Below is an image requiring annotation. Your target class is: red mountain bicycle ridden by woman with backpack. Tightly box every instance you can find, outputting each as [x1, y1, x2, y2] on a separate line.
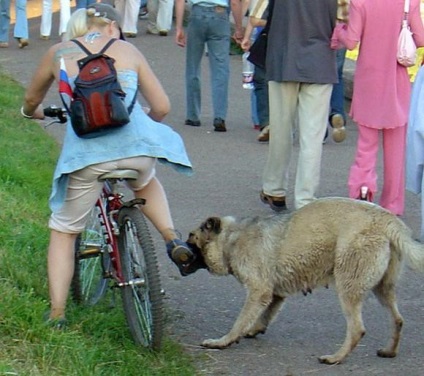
[44, 106, 164, 350]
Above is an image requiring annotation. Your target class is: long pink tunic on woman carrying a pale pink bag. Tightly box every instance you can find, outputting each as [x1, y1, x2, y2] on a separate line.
[332, 0, 424, 129]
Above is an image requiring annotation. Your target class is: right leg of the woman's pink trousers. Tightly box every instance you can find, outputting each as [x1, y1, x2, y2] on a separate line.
[380, 127, 406, 215]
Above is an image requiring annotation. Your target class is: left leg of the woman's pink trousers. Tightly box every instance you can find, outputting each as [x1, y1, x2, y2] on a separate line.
[348, 124, 379, 198]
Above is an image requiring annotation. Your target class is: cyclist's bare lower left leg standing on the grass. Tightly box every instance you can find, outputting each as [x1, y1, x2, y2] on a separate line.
[47, 230, 77, 319]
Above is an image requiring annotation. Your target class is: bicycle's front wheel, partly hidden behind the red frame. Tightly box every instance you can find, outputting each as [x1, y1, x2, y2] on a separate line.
[71, 207, 111, 306]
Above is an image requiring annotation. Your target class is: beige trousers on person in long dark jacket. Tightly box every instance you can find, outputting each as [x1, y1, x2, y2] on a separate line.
[263, 81, 333, 209]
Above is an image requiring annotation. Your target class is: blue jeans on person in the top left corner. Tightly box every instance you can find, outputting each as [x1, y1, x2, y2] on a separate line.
[0, 0, 28, 42]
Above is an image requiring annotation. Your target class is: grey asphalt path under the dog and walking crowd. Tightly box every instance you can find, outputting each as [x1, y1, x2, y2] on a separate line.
[0, 0, 424, 376]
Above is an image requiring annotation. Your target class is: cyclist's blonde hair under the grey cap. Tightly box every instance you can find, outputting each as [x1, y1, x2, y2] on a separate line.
[63, 8, 111, 41]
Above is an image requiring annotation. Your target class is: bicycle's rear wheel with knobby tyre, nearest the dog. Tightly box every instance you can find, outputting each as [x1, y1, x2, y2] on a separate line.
[118, 207, 163, 350]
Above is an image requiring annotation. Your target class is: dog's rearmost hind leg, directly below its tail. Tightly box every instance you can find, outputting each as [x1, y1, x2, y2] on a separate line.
[373, 259, 403, 358]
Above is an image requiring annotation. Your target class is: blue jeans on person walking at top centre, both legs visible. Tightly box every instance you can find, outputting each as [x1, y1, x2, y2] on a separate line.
[186, 5, 231, 120]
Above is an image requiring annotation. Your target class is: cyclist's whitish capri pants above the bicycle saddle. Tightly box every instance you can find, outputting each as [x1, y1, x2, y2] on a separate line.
[49, 157, 156, 234]
